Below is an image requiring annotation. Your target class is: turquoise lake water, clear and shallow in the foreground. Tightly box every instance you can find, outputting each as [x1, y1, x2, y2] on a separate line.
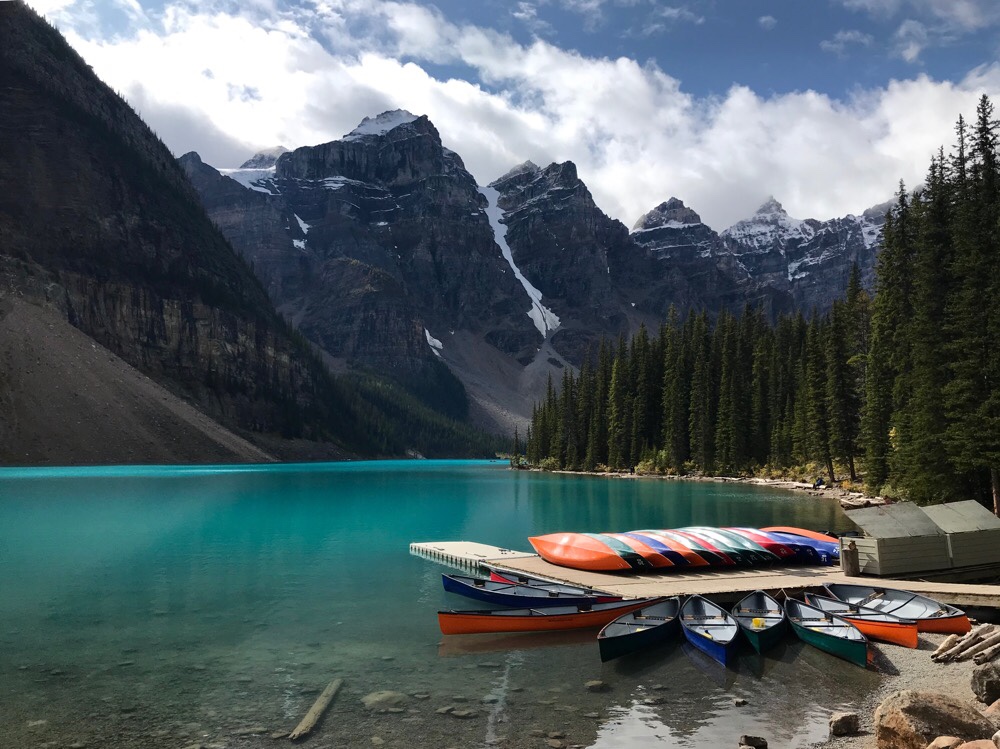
[0, 461, 878, 749]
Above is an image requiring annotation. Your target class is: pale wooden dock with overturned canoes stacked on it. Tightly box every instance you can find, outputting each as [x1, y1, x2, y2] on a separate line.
[410, 541, 1000, 609]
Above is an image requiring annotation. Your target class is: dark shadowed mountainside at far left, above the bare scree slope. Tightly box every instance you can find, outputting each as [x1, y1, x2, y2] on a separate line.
[0, 2, 368, 450]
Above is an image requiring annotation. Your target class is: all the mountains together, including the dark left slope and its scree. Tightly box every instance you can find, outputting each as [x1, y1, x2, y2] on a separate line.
[0, 0, 884, 464]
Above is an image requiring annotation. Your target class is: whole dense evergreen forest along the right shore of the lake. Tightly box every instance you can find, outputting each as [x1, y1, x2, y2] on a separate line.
[526, 96, 1000, 511]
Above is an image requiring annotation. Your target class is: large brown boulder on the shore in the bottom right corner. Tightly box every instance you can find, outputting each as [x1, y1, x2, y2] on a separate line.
[875, 689, 996, 749]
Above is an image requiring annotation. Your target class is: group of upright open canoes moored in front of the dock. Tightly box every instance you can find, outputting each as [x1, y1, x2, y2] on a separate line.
[438, 571, 970, 667]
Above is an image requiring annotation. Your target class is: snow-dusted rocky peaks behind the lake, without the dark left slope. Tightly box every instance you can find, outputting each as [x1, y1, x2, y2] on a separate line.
[179, 110, 888, 432]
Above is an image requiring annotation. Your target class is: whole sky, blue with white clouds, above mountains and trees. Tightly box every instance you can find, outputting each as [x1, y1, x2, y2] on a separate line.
[28, 0, 1000, 230]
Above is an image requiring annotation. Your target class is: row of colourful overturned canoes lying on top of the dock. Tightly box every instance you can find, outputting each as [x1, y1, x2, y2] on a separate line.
[528, 526, 840, 572]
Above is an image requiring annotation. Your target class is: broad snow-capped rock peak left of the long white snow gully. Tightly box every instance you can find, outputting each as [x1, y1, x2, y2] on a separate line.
[180, 111, 543, 426]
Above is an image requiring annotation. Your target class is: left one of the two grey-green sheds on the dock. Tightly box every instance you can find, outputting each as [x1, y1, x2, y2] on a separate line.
[841, 502, 951, 575]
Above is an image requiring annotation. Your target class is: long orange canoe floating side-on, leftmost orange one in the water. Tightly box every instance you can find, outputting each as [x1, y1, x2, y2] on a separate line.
[438, 598, 662, 635]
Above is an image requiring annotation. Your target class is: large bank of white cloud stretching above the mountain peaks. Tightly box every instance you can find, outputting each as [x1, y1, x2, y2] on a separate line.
[31, 0, 1000, 229]
